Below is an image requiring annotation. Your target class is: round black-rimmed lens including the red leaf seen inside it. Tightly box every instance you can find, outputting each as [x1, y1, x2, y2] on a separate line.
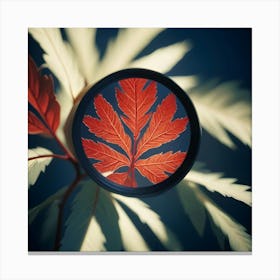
[72, 69, 200, 197]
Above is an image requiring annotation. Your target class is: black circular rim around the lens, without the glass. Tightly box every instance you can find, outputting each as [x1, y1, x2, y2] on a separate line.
[72, 68, 201, 197]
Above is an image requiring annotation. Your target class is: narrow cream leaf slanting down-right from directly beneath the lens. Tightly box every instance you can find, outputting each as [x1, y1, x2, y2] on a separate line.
[114, 195, 181, 251]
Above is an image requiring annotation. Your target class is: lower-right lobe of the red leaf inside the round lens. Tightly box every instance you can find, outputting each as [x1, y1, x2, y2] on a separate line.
[135, 152, 186, 184]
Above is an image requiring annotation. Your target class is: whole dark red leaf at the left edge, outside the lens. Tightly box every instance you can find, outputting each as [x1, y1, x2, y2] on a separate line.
[28, 57, 60, 135]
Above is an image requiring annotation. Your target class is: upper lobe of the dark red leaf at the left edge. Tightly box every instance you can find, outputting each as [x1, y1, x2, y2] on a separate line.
[28, 57, 60, 133]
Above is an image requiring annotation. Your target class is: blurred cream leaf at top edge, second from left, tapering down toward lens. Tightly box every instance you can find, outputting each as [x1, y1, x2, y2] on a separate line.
[65, 28, 99, 84]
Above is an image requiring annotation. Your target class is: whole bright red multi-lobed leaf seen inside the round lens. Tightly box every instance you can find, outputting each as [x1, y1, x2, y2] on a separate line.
[82, 78, 189, 187]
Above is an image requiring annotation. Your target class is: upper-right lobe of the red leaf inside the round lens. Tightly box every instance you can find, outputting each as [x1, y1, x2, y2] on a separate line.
[136, 93, 188, 159]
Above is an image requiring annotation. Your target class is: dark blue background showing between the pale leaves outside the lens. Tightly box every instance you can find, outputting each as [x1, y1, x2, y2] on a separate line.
[28, 28, 251, 251]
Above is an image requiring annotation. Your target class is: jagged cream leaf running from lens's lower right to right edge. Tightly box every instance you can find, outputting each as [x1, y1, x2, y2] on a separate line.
[184, 167, 252, 206]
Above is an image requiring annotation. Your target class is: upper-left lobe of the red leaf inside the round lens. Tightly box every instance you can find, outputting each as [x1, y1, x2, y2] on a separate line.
[83, 94, 131, 157]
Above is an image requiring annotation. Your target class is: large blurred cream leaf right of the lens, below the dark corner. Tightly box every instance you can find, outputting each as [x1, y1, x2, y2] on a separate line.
[190, 82, 252, 148]
